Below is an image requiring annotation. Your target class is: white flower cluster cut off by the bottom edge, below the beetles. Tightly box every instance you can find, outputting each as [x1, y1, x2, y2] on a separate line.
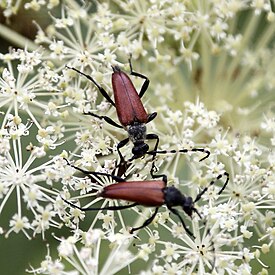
[28, 229, 137, 274]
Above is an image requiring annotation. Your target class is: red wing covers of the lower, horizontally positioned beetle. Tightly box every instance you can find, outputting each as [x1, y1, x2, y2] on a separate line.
[101, 180, 166, 206]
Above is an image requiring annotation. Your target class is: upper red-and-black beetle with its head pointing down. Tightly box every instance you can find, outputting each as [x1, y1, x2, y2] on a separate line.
[67, 58, 159, 162]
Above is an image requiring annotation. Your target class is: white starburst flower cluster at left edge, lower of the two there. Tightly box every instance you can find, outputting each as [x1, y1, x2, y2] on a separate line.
[0, 114, 60, 239]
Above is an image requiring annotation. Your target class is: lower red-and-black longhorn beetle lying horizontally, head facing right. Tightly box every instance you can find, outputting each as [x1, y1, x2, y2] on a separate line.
[62, 159, 229, 238]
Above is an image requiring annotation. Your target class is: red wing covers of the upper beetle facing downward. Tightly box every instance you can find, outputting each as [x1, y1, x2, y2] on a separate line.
[112, 67, 148, 126]
